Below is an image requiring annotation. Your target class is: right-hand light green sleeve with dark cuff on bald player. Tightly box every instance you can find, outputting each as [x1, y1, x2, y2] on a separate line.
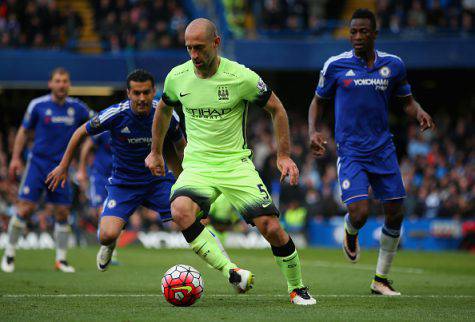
[240, 68, 272, 107]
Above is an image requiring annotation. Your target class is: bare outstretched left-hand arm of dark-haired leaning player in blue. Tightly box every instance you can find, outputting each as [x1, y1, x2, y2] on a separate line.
[45, 123, 88, 191]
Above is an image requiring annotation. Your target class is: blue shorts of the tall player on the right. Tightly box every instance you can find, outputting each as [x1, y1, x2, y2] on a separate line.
[337, 145, 406, 205]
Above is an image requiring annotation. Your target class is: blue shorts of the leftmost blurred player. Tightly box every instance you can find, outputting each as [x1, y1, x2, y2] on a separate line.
[18, 155, 72, 206]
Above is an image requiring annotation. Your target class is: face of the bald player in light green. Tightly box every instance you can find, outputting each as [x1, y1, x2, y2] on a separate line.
[185, 31, 221, 71]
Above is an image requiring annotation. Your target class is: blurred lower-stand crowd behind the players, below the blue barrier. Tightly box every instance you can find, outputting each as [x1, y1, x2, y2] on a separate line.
[0, 110, 475, 232]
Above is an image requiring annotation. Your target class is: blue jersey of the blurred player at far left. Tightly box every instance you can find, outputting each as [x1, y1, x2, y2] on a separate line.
[22, 95, 94, 162]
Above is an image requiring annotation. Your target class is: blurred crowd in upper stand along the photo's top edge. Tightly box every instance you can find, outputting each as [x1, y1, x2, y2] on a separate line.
[0, 0, 475, 52]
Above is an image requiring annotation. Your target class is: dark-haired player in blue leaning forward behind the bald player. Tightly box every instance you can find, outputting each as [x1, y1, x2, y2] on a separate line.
[47, 69, 186, 271]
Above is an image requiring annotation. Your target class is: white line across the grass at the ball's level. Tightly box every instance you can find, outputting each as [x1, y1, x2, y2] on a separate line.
[0, 294, 475, 299]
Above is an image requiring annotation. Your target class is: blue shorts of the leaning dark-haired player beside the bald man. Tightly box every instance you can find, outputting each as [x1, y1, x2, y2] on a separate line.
[101, 180, 175, 223]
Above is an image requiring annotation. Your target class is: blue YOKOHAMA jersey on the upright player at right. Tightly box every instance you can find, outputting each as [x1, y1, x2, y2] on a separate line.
[315, 51, 411, 156]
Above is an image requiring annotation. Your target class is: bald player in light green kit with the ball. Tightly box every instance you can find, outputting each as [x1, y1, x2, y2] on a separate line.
[146, 18, 316, 305]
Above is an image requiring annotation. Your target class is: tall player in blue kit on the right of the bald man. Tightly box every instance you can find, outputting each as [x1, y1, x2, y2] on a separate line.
[309, 9, 434, 295]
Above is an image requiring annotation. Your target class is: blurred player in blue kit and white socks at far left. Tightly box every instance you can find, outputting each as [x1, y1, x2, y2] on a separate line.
[1, 68, 92, 273]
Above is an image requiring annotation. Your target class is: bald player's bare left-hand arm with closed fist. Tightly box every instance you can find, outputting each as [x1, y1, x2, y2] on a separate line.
[145, 99, 173, 176]
